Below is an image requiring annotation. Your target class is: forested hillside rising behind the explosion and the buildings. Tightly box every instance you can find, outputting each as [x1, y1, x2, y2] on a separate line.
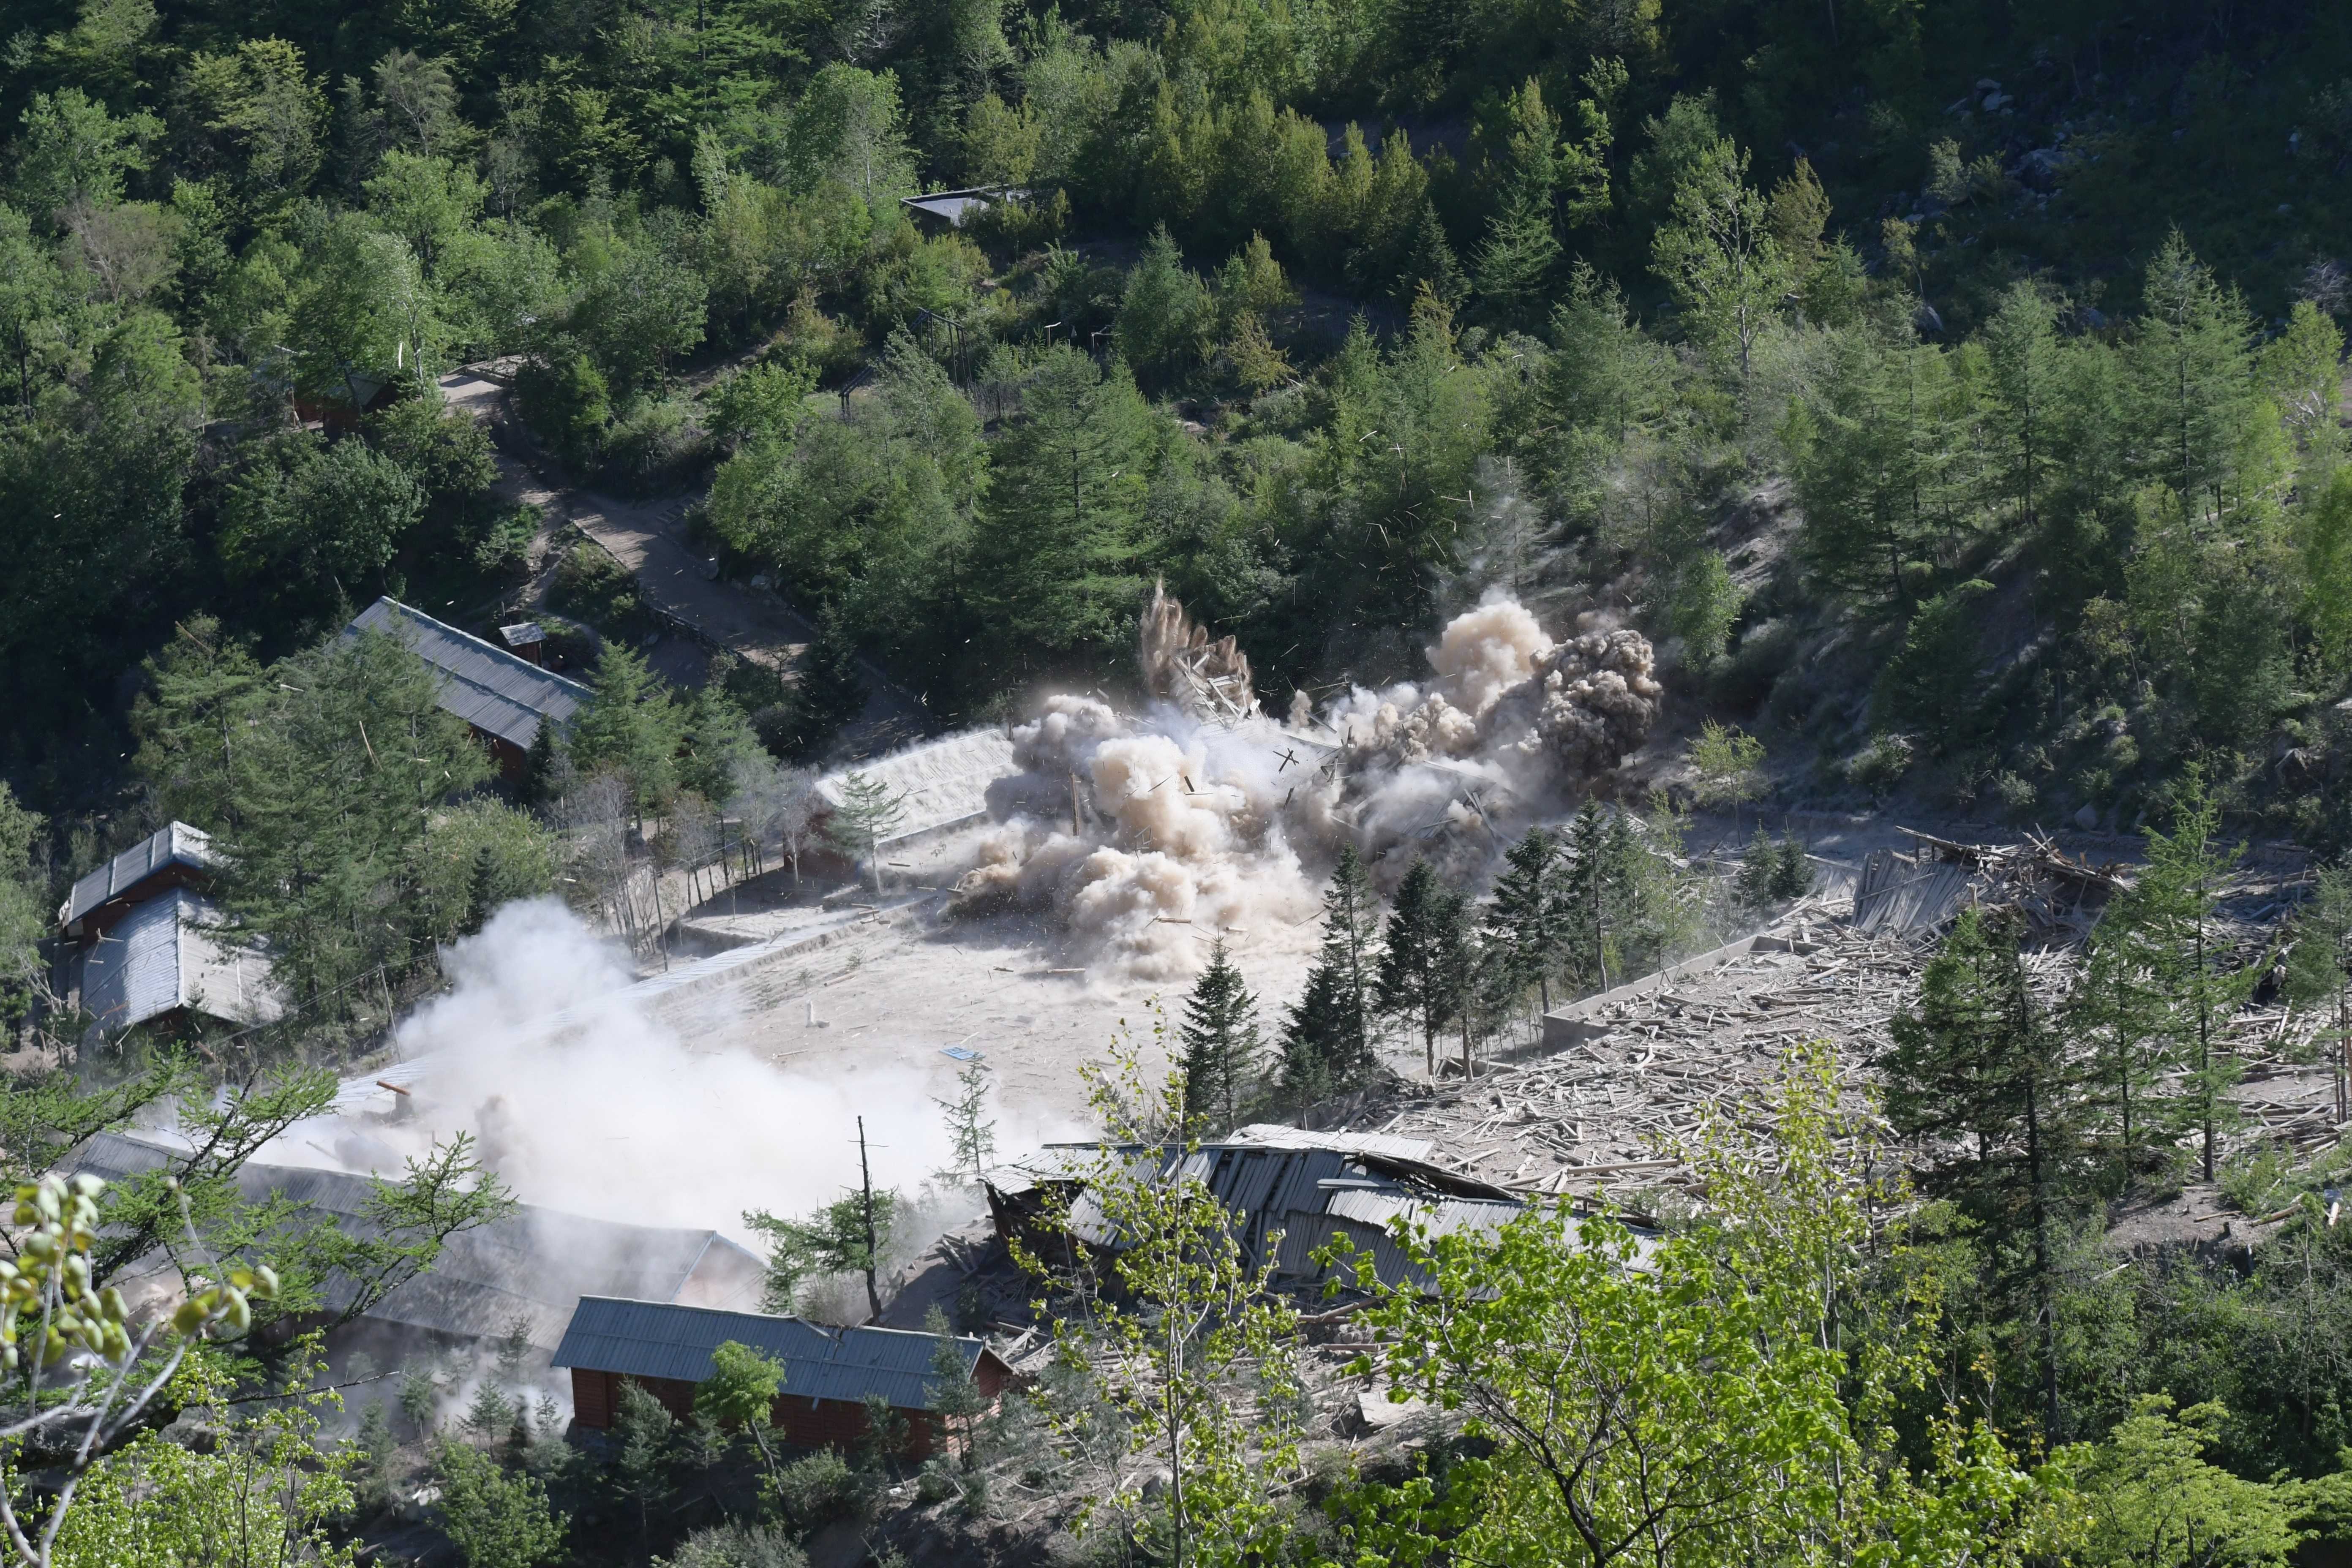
[0, 0, 2352, 860]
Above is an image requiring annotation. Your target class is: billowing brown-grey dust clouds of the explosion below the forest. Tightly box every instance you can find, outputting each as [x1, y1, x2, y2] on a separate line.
[957, 590, 1660, 980]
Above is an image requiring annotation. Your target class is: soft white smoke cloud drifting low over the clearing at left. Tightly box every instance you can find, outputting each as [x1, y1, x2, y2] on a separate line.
[261, 898, 1082, 1251]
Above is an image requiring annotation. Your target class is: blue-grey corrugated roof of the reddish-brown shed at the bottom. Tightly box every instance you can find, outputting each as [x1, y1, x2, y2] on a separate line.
[555, 1295, 983, 1410]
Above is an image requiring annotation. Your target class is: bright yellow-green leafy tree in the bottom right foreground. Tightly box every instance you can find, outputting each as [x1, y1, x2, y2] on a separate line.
[1341, 1053, 2063, 1563]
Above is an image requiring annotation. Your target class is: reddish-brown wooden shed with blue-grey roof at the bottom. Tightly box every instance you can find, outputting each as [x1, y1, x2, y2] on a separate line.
[555, 1295, 1011, 1460]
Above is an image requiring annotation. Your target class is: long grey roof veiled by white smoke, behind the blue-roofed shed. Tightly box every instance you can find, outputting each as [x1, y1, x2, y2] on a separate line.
[71, 1133, 764, 1349]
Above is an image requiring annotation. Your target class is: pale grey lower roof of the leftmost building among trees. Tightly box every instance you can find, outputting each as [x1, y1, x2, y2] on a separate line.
[82, 889, 285, 1030]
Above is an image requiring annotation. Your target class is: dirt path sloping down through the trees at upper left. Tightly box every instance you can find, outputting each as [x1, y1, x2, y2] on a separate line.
[440, 371, 929, 752]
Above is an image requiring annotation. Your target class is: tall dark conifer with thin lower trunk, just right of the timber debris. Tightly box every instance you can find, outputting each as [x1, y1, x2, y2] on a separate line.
[1879, 910, 2084, 1439]
